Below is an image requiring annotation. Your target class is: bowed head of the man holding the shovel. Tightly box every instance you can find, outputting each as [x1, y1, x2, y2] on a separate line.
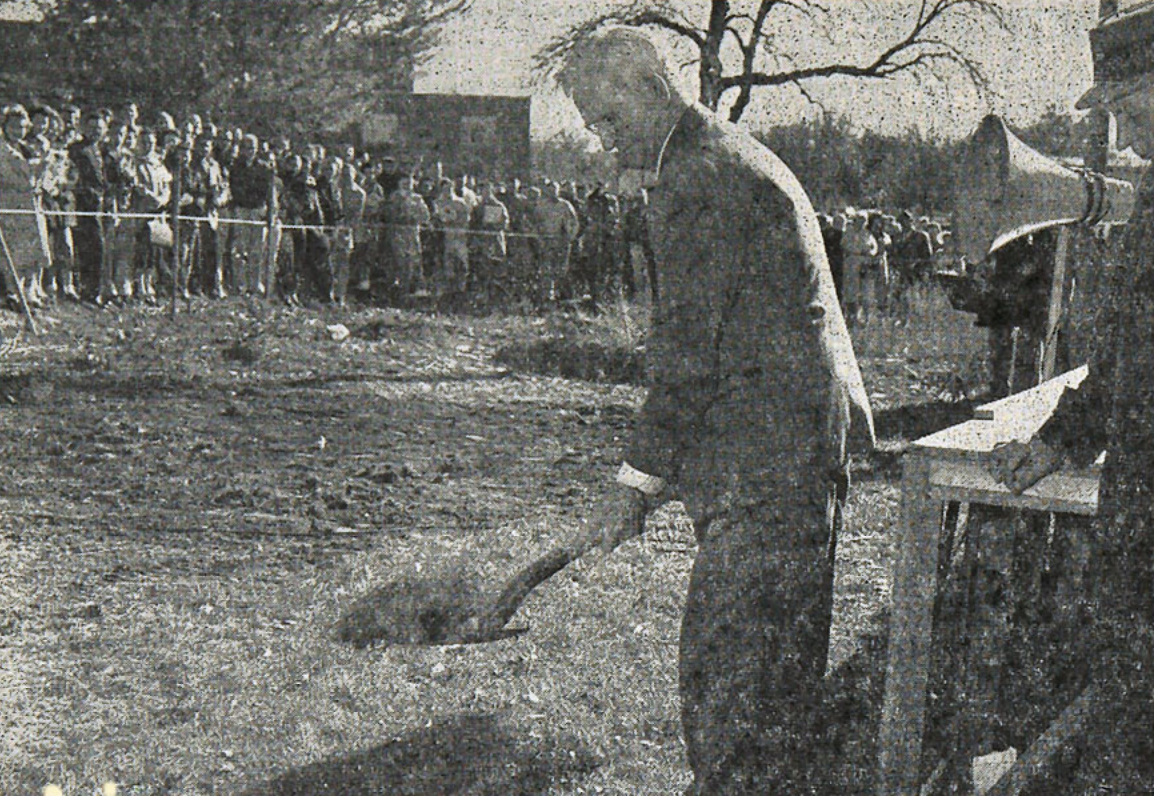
[557, 28, 688, 170]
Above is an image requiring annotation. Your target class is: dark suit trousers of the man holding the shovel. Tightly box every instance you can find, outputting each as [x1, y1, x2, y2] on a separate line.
[680, 485, 840, 796]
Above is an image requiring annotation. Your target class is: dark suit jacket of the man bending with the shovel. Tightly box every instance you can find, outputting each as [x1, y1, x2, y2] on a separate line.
[627, 105, 874, 516]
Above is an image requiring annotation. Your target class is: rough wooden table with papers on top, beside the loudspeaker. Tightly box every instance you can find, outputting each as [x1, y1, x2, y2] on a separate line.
[878, 367, 1099, 796]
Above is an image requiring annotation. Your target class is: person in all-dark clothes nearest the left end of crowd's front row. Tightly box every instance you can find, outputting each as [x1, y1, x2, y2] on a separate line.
[68, 111, 113, 300]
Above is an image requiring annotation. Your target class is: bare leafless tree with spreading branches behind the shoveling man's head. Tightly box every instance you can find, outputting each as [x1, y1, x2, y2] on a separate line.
[535, 0, 1007, 121]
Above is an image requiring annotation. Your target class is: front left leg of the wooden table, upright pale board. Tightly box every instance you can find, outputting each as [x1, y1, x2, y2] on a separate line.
[877, 451, 942, 796]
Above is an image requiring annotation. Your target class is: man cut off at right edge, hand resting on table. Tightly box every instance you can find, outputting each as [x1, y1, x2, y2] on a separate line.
[995, 5, 1154, 794]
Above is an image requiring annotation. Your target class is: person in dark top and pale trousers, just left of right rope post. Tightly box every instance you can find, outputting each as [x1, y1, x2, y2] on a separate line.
[227, 135, 279, 295]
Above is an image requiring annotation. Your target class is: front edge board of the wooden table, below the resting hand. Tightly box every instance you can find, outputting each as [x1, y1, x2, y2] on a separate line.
[930, 461, 1099, 517]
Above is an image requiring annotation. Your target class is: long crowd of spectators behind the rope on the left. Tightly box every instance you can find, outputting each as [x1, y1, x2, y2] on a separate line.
[0, 99, 657, 308]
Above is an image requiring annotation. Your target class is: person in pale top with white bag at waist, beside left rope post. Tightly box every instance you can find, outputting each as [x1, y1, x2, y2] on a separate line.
[133, 129, 172, 303]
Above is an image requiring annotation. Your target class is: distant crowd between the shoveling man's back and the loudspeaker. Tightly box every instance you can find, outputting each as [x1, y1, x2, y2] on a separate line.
[818, 208, 950, 328]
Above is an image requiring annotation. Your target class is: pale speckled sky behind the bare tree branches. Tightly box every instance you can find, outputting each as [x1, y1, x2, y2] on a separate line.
[417, 0, 1103, 137]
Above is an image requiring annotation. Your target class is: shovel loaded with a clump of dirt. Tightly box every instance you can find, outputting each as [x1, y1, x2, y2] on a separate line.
[336, 526, 601, 647]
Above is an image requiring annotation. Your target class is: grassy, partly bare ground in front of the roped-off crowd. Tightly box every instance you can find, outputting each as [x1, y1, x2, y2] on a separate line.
[0, 287, 982, 796]
